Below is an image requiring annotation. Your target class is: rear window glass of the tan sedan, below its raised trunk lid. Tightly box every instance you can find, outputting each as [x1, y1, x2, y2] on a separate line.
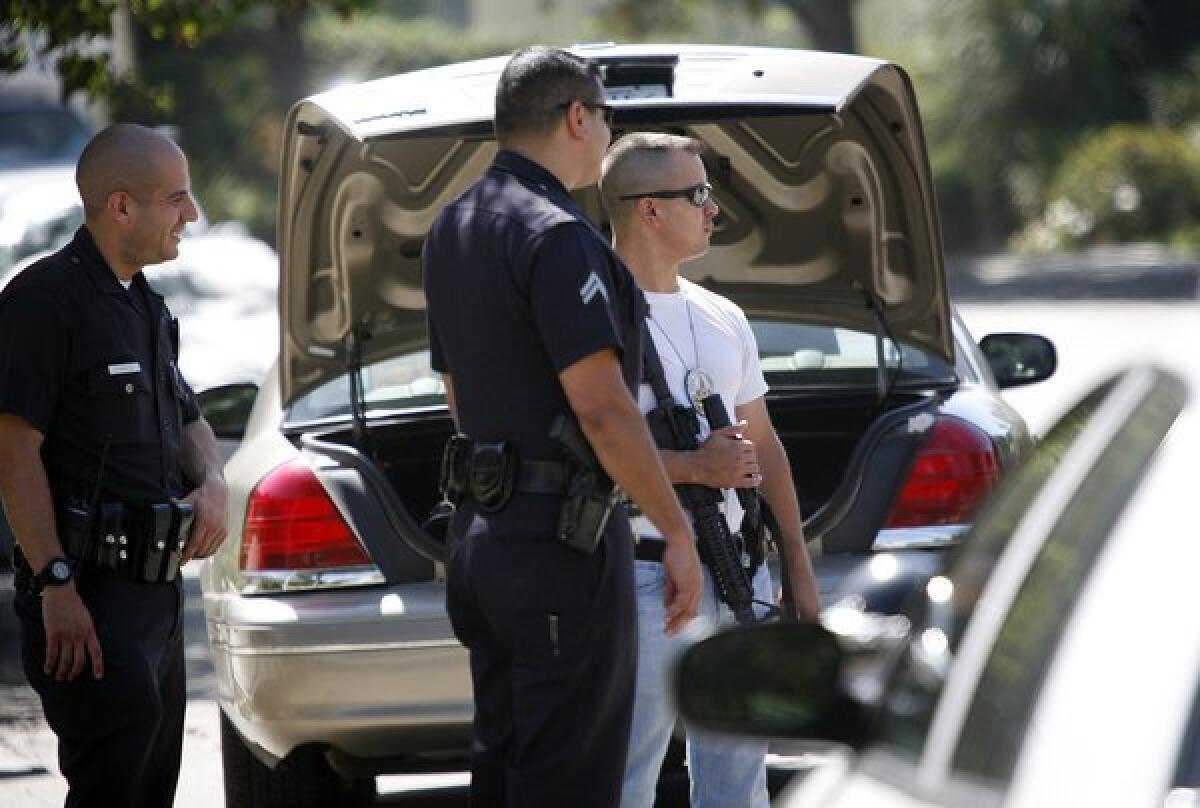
[288, 321, 954, 423]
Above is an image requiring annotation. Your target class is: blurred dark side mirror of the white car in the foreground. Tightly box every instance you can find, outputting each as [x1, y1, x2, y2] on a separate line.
[674, 623, 865, 747]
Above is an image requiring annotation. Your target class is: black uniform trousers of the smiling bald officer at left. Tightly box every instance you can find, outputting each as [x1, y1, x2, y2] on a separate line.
[16, 567, 187, 808]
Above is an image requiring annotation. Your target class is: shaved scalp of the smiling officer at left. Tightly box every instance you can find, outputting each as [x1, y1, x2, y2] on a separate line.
[76, 124, 182, 222]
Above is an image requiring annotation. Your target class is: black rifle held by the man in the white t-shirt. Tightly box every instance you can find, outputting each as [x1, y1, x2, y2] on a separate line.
[644, 324, 757, 623]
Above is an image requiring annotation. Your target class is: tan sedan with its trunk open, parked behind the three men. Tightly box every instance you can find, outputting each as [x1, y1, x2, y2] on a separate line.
[202, 46, 1055, 806]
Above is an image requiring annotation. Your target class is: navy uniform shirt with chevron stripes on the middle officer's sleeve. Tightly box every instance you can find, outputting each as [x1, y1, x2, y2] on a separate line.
[422, 151, 644, 533]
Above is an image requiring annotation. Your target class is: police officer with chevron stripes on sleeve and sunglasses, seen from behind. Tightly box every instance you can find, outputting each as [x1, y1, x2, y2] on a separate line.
[424, 47, 701, 808]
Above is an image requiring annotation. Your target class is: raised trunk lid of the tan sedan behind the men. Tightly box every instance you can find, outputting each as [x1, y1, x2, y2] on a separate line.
[278, 46, 953, 406]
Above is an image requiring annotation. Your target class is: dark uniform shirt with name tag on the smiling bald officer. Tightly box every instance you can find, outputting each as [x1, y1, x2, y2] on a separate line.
[0, 227, 199, 504]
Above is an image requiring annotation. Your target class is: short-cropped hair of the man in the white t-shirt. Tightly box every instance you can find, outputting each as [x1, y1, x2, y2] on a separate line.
[600, 132, 704, 227]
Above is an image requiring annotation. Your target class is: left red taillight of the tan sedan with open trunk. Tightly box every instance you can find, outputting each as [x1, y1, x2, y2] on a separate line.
[240, 460, 373, 571]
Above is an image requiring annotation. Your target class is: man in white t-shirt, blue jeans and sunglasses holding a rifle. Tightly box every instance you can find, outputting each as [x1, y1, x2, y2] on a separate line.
[600, 132, 817, 808]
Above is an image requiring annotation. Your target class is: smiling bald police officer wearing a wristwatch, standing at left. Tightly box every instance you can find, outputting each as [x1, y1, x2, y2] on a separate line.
[0, 124, 227, 808]
